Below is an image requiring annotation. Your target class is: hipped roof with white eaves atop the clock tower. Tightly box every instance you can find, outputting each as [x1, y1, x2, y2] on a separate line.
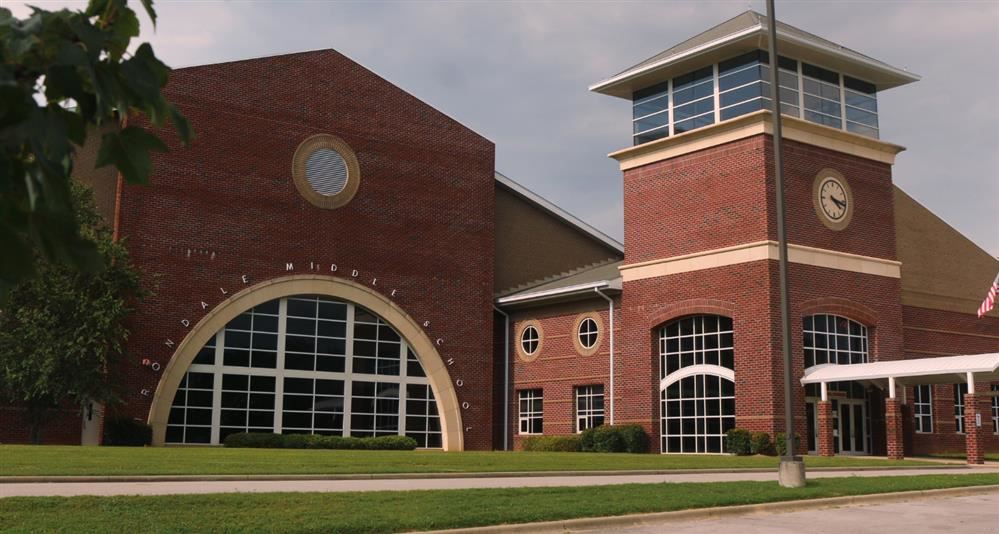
[590, 10, 920, 99]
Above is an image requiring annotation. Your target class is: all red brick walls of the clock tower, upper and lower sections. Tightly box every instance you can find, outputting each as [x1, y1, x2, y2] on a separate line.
[618, 135, 903, 454]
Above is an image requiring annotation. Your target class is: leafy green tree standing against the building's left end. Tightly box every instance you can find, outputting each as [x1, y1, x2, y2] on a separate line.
[0, 183, 148, 443]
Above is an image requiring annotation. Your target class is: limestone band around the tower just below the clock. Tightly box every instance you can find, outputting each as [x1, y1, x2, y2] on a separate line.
[620, 241, 902, 282]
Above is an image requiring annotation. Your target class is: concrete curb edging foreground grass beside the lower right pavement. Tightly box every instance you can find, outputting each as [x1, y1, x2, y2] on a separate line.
[422, 485, 999, 534]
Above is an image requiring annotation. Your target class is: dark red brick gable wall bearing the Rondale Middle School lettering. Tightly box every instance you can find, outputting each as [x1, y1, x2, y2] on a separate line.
[0, 50, 495, 449]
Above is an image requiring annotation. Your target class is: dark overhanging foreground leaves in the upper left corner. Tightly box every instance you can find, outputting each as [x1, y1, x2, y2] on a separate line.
[0, 0, 192, 303]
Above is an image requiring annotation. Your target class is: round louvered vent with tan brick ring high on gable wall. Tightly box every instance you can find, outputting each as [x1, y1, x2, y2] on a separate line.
[291, 134, 361, 209]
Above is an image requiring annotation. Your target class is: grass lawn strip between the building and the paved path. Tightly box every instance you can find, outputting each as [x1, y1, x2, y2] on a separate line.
[0, 445, 937, 476]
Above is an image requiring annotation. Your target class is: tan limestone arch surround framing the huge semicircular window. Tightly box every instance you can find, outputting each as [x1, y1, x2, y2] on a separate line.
[148, 275, 464, 451]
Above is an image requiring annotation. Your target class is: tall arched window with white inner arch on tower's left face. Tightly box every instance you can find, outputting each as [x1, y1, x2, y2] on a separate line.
[659, 315, 735, 453]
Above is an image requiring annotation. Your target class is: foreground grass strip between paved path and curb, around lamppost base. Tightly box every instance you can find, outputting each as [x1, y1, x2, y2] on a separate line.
[0, 474, 999, 533]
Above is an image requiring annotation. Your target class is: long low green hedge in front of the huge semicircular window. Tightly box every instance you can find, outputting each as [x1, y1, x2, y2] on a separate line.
[223, 432, 417, 451]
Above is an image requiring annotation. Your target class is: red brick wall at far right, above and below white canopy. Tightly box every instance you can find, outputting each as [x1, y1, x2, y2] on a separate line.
[902, 306, 999, 454]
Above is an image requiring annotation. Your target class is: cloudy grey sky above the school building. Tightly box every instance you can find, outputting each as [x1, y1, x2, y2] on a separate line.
[13, 0, 999, 256]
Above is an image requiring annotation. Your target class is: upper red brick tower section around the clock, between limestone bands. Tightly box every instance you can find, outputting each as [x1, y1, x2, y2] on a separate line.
[624, 135, 896, 264]
